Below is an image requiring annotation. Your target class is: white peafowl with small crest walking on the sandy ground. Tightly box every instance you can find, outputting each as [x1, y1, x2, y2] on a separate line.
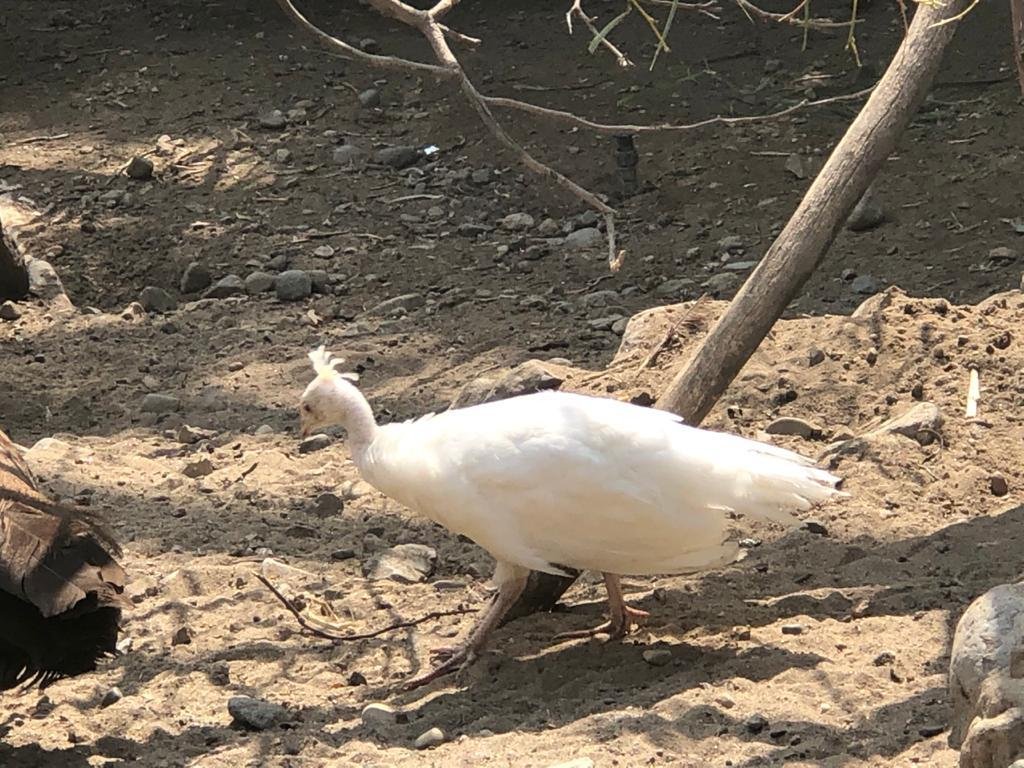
[300, 347, 840, 688]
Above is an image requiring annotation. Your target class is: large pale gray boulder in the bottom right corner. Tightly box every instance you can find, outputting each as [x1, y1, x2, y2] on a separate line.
[949, 584, 1024, 768]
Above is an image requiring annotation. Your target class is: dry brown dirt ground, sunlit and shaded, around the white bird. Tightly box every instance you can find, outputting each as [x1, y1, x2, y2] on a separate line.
[0, 0, 1024, 768]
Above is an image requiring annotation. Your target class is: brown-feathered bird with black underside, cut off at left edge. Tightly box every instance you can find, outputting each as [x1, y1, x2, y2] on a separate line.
[0, 431, 130, 690]
